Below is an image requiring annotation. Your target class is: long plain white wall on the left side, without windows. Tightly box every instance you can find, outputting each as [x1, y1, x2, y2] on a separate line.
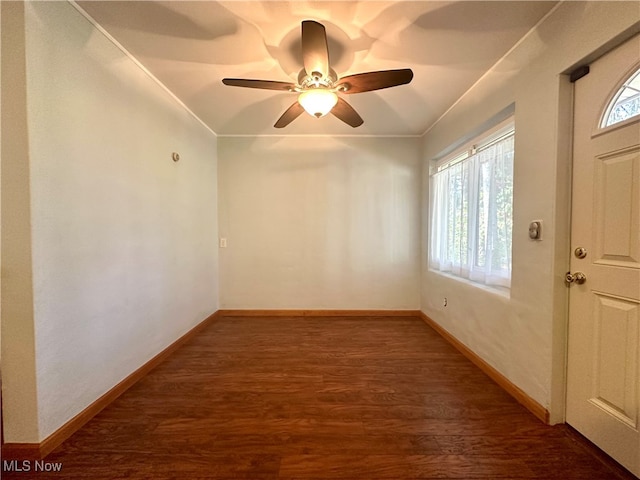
[2, 2, 218, 442]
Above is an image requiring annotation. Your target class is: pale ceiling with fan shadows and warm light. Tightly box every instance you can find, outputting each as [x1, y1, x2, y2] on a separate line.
[77, 1, 556, 135]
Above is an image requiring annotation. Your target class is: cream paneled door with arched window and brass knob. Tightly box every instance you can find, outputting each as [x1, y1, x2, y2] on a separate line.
[567, 32, 640, 477]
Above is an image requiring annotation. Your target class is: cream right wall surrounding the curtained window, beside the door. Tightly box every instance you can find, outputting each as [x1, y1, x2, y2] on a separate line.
[422, 2, 640, 422]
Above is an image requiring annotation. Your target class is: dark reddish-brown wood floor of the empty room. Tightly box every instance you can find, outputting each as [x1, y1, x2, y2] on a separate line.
[3, 317, 634, 480]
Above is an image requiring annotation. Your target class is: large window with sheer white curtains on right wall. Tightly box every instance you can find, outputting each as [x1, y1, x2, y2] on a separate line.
[429, 120, 515, 288]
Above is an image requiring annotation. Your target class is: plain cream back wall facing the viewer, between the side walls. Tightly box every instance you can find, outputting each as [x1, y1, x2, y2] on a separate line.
[218, 136, 421, 309]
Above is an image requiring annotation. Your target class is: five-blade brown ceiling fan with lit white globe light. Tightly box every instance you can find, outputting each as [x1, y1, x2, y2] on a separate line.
[222, 20, 413, 128]
